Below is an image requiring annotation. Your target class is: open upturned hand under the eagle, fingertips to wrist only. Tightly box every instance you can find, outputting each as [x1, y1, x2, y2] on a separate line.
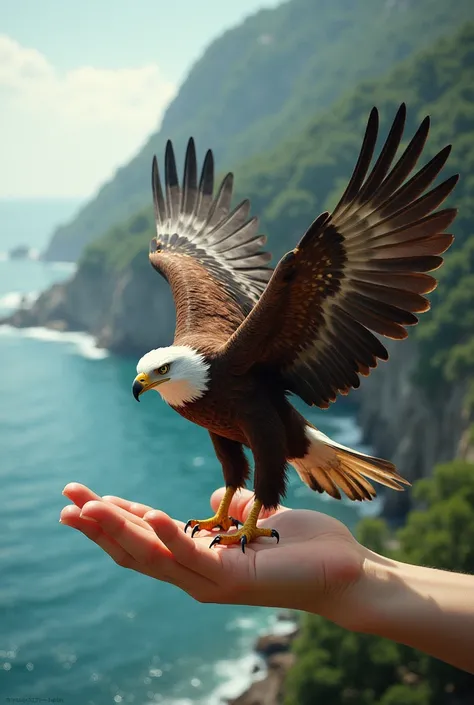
[60, 483, 370, 629]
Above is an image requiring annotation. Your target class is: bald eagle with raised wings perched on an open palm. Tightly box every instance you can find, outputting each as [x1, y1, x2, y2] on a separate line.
[132, 104, 458, 551]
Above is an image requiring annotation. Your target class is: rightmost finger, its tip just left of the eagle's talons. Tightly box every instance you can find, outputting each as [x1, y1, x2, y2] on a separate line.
[144, 509, 222, 580]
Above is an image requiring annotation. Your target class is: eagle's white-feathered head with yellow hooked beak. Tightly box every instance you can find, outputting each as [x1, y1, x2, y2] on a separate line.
[132, 345, 209, 406]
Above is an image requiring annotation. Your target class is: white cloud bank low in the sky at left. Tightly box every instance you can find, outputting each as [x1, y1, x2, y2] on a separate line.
[0, 35, 175, 197]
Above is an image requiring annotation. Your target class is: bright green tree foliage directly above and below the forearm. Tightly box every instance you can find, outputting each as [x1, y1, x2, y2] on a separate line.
[285, 461, 474, 705]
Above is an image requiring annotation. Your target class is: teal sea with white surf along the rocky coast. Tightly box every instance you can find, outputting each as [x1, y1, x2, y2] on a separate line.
[0, 200, 378, 705]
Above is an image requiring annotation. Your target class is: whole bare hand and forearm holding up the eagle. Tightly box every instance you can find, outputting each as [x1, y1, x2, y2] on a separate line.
[60, 483, 474, 673]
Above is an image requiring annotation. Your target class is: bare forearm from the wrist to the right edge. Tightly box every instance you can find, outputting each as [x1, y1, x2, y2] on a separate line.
[361, 553, 474, 673]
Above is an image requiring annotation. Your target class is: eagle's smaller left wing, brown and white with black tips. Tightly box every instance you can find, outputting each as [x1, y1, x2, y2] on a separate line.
[150, 138, 272, 340]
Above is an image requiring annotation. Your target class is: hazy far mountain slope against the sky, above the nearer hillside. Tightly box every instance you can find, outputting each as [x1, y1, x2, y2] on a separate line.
[45, 0, 474, 259]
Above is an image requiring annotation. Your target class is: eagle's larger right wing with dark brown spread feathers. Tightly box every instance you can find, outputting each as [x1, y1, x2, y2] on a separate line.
[223, 105, 458, 408]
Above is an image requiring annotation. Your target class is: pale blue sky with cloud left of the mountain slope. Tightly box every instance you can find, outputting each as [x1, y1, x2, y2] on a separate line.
[0, 0, 281, 199]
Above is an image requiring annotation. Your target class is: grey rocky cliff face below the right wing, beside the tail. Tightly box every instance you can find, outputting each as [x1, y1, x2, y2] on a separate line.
[355, 334, 469, 518]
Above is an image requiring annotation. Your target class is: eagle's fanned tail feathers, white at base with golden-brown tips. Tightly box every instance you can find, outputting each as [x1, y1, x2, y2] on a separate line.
[289, 426, 410, 501]
